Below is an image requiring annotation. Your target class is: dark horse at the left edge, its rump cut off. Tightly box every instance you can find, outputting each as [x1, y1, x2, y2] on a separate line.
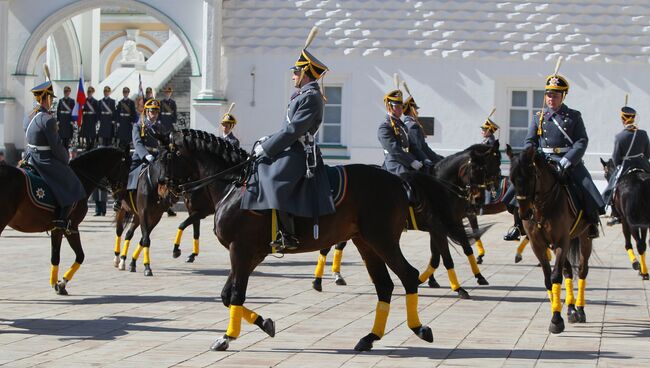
[0, 148, 131, 295]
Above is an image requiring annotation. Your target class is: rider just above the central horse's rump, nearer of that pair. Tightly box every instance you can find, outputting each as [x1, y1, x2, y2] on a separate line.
[377, 89, 424, 177]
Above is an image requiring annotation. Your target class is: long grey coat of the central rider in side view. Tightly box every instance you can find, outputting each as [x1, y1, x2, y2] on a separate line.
[241, 82, 335, 217]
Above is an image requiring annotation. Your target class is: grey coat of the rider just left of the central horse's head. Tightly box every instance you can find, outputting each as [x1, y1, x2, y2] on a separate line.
[126, 118, 162, 190]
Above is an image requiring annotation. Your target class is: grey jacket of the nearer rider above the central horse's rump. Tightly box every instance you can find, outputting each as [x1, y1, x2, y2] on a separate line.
[377, 115, 416, 176]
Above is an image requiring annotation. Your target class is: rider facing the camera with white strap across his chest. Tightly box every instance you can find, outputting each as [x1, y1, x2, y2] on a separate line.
[524, 74, 605, 239]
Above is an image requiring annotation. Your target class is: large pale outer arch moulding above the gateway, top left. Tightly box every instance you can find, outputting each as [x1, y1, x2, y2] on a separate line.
[15, 0, 201, 76]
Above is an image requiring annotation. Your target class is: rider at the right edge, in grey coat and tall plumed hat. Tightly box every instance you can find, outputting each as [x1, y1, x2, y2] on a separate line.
[603, 106, 650, 226]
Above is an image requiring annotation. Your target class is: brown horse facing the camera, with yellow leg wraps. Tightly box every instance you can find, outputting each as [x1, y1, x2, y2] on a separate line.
[510, 147, 592, 334]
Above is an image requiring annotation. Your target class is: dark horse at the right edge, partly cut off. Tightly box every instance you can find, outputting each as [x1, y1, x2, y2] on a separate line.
[600, 158, 650, 280]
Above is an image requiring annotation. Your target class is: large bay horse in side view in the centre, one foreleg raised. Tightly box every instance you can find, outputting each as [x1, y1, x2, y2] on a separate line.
[164, 130, 444, 351]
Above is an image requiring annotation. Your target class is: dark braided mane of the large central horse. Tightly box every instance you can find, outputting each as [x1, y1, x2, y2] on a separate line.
[173, 129, 248, 166]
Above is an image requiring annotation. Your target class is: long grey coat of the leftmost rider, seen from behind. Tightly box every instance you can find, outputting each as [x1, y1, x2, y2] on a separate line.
[23, 108, 87, 207]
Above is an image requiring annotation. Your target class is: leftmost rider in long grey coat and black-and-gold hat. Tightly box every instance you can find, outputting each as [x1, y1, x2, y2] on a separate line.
[23, 81, 86, 230]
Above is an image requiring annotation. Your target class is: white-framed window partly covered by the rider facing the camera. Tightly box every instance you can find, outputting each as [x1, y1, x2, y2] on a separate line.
[509, 89, 544, 149]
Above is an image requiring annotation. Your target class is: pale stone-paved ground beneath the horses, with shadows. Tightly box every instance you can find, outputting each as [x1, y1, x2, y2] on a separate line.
[0, 212, 650, 368]
